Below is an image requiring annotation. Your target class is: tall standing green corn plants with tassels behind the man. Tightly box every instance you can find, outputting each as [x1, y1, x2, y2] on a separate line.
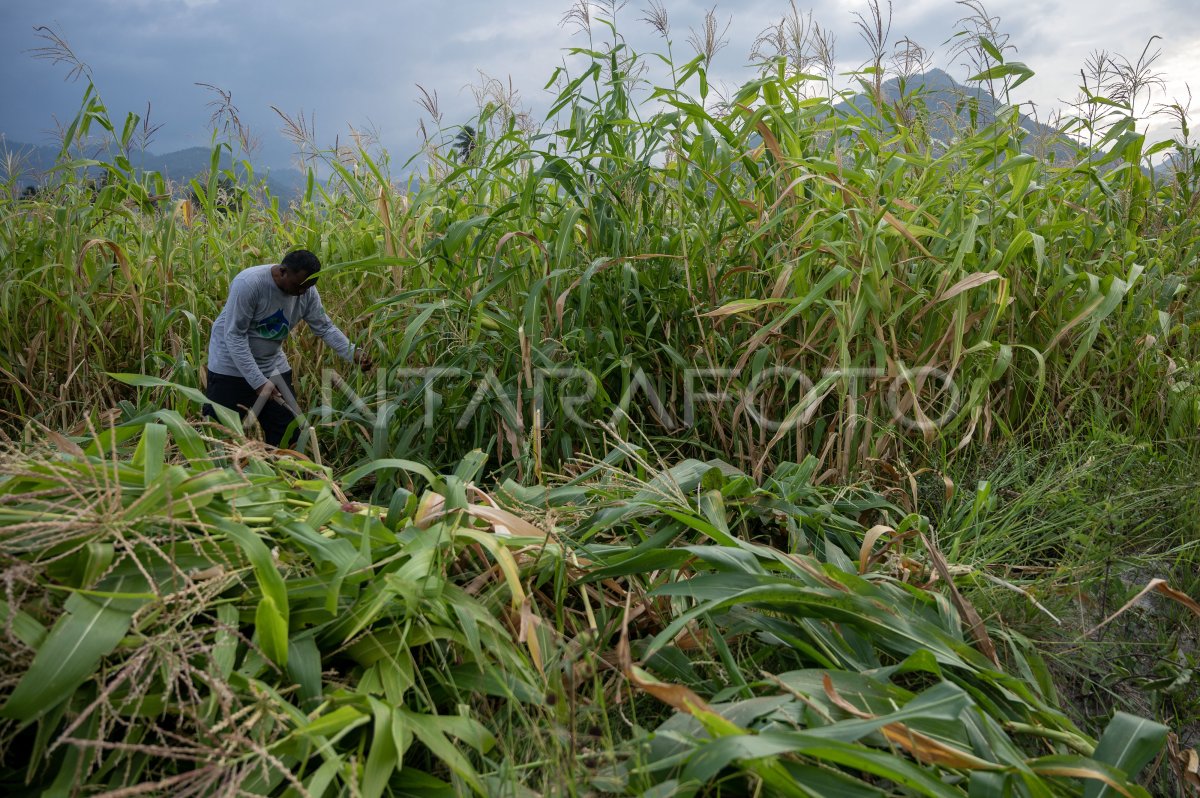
[0, 10, 1200, 478]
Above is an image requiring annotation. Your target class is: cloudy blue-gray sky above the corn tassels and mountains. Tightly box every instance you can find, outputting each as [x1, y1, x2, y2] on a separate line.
[0, 0, 1200, 163]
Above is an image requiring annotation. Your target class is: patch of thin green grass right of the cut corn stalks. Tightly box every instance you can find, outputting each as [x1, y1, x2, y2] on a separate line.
[926, 428, 1200, 777]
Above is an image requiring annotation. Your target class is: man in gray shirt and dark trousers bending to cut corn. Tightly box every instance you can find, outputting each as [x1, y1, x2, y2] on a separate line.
[204, 250, 372, 446]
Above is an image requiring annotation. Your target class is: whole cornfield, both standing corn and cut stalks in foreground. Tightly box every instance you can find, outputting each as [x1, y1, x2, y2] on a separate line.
[0, 7, 1200, 798]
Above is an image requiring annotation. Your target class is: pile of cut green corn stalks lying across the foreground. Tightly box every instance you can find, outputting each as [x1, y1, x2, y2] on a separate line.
[0, 421, 1168, 797]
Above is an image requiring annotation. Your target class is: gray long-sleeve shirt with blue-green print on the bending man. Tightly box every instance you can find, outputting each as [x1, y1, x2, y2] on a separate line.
[209, 264, 354, 390]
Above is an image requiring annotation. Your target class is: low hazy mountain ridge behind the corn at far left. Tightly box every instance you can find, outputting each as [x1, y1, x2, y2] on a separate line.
[0, 139, 306, 205]
